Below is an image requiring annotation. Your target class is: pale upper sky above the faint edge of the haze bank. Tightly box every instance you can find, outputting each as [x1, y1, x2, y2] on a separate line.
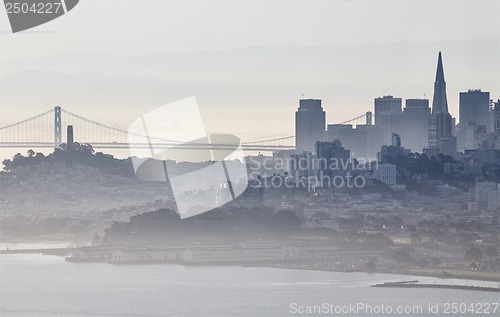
[0, 0, 500, 60]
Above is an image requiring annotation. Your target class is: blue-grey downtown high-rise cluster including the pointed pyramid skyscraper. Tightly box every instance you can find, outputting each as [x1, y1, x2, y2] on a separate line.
[295, 52, 500, 157]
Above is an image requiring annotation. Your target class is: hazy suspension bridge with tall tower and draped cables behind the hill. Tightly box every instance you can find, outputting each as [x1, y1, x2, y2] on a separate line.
[0, 106, 364, 152]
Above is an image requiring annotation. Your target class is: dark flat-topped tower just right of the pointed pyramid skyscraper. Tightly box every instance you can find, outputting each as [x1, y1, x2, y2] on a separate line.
[460, 89, 490, 130]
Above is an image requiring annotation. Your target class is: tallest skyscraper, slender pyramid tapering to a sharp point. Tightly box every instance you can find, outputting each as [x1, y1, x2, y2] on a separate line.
[429, 52, 456, 155]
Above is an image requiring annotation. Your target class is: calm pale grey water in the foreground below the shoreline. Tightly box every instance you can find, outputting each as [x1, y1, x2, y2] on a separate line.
[0, 254, 500, 317]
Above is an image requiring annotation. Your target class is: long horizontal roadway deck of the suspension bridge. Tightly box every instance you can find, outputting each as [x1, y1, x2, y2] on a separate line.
[0, 142, 295, 151]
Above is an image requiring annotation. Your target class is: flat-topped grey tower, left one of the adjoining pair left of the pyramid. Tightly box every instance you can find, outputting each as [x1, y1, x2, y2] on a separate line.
[374, 96, 403, 144]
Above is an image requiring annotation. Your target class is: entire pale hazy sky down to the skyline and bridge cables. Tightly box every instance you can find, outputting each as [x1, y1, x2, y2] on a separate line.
[0, 0, 500, 148]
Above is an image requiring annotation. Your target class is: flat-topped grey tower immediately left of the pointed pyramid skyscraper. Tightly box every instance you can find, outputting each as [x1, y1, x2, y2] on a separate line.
[399, 99, 431, 152]
